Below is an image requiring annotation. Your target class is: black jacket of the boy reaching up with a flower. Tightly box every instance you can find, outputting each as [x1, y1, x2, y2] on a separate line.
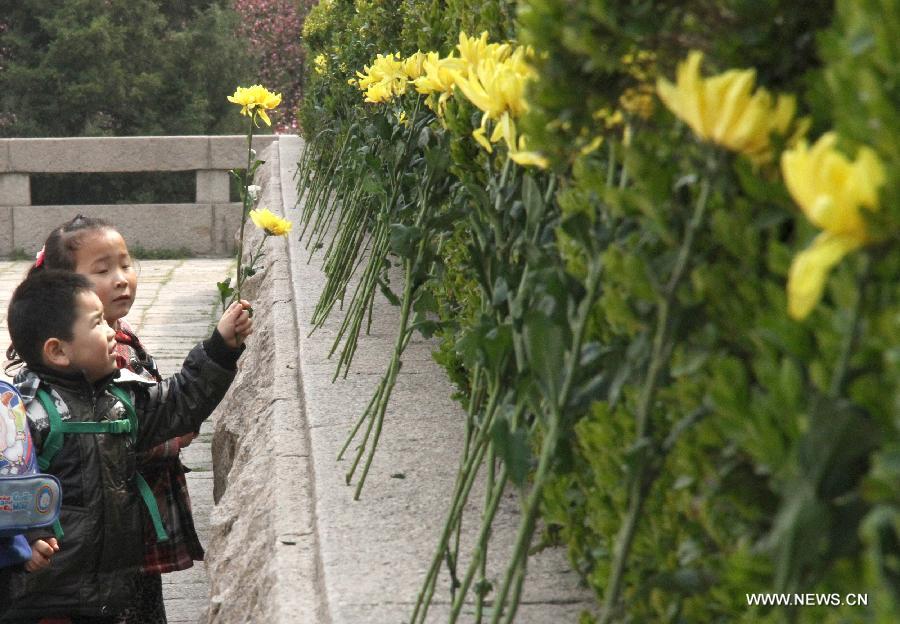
[0, 332, 240, 620]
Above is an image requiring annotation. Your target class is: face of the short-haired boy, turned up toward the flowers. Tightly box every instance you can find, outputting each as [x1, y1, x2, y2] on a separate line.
[60, 292, 117, 382]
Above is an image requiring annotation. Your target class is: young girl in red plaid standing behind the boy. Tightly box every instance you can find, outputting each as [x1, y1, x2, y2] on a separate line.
[27, 215, 209, 624]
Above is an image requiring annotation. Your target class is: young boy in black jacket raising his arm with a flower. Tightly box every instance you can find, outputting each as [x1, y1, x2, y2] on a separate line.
[3, 270, 252, 624]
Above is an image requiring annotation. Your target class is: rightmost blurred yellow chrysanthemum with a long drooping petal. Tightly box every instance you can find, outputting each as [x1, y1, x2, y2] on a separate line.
[781, 132, 885, 319]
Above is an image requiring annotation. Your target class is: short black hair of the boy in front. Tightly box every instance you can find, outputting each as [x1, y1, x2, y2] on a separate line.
[6, 269, 92, 372]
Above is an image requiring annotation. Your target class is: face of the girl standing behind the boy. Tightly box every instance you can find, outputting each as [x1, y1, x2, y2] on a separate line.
[75, 228, 137, 325]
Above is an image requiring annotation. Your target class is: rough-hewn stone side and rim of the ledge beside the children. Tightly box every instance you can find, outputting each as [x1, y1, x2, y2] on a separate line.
[206, 147, 328, 624]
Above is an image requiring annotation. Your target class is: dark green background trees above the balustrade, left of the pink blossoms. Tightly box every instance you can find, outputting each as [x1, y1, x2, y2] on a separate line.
[0, 0, 253, 136]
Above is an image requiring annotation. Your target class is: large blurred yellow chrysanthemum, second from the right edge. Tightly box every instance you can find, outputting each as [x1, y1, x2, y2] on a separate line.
[656, 51, 796, 165]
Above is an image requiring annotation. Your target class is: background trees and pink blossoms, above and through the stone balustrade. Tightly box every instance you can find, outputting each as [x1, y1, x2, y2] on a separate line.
[0, 0, 308, 204]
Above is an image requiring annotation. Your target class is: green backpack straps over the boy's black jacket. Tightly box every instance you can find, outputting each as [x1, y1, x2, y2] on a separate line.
[36, 385, 169, 542]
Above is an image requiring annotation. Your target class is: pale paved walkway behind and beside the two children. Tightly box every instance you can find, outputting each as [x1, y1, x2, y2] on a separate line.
[0, 258, 233, 624]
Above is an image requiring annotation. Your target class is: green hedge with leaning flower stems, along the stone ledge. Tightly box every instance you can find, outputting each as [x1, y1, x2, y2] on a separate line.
[300, 0, 900, 622]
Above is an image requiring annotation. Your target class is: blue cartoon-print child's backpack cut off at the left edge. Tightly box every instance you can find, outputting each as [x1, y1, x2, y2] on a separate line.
[0, 381, 62, 568]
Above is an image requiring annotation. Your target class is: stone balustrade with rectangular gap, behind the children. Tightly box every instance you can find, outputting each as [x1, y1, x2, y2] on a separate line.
[0, 135, 277, 256]
